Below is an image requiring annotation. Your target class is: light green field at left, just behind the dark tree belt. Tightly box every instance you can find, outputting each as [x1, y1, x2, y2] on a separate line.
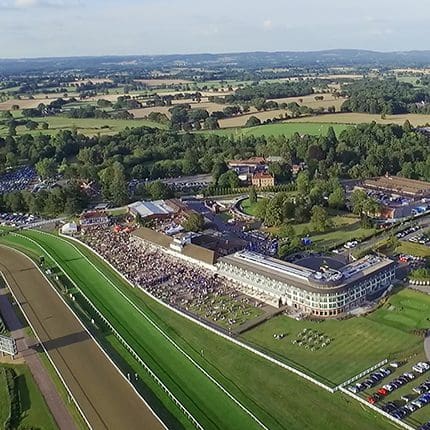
[0, 117, 165, 136]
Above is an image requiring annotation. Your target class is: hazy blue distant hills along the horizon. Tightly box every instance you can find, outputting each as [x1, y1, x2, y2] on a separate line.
[0, 49, 430, 74]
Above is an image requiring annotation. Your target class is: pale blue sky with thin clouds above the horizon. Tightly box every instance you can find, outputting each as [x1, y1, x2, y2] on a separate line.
[0, 0, 430, 58]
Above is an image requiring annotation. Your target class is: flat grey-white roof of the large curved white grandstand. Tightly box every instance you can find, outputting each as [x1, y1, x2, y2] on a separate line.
[221, 251, 394, 293]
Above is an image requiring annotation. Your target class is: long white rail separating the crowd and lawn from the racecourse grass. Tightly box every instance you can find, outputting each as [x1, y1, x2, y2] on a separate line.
[60, 232, 337, 394]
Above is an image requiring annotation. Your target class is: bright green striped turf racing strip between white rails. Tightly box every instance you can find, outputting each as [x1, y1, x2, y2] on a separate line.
[5, 231, 261, 429]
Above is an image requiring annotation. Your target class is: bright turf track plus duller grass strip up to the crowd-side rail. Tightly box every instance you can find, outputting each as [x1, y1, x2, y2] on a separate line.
[1, 231, 400, 430]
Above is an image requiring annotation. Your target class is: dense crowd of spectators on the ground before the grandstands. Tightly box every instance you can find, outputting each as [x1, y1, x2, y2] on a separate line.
[82, 227, 262, 328]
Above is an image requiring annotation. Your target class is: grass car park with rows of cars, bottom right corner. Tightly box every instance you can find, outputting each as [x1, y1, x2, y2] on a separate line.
[348, 360, 430, 430]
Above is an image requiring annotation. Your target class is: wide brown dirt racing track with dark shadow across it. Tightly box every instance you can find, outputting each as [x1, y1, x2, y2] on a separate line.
[0, 246, 165, 430]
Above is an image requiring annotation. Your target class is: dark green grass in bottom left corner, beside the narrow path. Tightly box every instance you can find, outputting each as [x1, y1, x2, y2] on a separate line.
[0, 365, 57, 430]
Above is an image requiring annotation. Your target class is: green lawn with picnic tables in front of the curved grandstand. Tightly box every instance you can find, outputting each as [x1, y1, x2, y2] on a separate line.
[243, 290, 430, 384]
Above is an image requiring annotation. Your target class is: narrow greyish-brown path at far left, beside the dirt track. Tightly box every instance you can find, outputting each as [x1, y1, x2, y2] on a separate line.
[0, 288, 76, 430]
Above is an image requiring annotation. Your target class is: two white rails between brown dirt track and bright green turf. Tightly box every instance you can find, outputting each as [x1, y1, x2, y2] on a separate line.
[6, 233, 194, 430]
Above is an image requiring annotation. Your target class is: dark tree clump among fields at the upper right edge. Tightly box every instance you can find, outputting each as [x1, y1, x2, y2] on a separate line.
[341, 78, 430, 115]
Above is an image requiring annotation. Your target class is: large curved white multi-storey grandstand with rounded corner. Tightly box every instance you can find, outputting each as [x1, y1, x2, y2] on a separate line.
[217, 251, 395, 318]
